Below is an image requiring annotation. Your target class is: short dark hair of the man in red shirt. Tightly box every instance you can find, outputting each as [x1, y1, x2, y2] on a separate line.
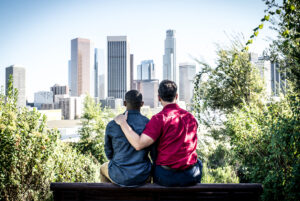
[158, 80, 177, 102]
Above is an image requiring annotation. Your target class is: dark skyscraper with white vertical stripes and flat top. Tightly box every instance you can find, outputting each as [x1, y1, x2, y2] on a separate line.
[107, 36, 130, 100]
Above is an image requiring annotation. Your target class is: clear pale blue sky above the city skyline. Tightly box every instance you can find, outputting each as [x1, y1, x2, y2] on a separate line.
[0, 0, 272, 101]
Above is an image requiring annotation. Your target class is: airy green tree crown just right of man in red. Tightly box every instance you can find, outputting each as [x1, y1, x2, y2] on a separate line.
[194, 39, 263, 118]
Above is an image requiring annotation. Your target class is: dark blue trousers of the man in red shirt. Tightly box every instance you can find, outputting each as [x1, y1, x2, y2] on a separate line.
[153, 159, 202, 186]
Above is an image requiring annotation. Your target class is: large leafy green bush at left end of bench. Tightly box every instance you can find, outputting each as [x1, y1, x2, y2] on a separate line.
[0, 77, 99, 200]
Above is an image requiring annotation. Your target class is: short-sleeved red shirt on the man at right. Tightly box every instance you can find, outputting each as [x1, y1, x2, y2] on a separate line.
[143, 103, 198, 169]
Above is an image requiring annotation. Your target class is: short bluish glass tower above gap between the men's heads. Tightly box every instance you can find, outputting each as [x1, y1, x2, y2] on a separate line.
[137, 60, 155, 80]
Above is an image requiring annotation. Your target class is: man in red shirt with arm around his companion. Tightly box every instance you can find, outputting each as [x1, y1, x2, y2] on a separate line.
[114, 80, 202, 186]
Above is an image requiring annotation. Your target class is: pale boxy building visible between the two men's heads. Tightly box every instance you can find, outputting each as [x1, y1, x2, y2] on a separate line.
[133, 79, 159, 108]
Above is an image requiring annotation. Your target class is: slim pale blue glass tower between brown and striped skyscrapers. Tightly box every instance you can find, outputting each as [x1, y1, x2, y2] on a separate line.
[98, 49, 107, 99]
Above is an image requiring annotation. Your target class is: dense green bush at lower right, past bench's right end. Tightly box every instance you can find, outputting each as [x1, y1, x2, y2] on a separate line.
[226, 95, 300, 200]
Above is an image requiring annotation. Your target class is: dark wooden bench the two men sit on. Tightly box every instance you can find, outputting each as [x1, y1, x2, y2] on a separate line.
[50, 183, 263, 201]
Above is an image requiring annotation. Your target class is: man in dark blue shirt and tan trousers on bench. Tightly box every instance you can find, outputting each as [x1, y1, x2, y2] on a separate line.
[100, 90, 151, 186]
